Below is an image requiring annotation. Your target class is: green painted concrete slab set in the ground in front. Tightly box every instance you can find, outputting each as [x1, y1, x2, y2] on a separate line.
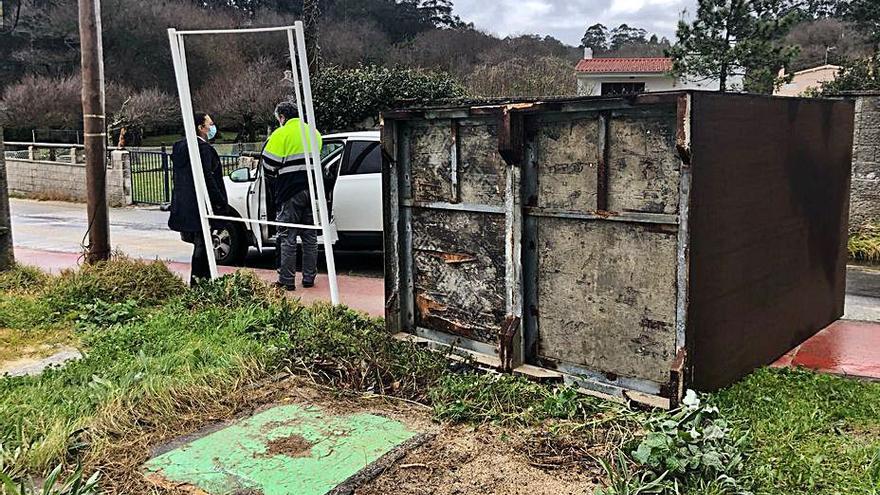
[146, 405, 416, 495]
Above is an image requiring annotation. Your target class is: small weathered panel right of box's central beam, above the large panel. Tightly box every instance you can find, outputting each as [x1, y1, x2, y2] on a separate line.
[536, 115, 601, 212]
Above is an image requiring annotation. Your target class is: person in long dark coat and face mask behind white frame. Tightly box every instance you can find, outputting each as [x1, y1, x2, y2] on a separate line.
[168, 112, 229, 285]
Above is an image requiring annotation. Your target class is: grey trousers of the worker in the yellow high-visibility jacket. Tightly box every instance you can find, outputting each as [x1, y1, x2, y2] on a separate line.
[277, 189, 318, 286]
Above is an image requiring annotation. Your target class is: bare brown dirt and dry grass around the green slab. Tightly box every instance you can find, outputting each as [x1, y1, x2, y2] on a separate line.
[134, 377, 598, 495]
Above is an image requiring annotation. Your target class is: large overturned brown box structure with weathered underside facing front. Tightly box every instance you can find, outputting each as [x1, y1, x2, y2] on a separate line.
[382, 92, 853, 405]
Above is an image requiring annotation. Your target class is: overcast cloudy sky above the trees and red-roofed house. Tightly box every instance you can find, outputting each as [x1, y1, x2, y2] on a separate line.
[454, 0, 697, 46]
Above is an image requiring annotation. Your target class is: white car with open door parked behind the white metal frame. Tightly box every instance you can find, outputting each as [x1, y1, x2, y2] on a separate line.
[212, 131, 382, 265]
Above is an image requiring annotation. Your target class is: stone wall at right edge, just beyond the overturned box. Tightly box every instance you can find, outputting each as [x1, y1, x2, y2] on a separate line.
[849, 94, 880, 231]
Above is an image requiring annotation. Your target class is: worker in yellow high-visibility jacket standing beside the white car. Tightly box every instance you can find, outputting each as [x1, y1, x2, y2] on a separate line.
[262, 102, 323, 291]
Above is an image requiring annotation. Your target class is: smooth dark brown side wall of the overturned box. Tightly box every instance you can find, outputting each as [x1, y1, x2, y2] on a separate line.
[687, 93, 853, 390]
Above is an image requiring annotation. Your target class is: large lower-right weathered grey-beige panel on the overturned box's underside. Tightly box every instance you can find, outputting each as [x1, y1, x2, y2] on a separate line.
[537, 218, 677, 382]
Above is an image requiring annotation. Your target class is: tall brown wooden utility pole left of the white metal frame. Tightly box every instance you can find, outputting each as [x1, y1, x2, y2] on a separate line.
[79, 0, 110, 263]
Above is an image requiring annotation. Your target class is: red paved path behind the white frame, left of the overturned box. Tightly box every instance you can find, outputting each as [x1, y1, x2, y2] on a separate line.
[15, 247, 385, 316]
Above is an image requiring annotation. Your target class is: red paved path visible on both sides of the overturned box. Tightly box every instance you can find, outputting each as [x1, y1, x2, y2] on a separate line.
[15, 247, 880, 380]
